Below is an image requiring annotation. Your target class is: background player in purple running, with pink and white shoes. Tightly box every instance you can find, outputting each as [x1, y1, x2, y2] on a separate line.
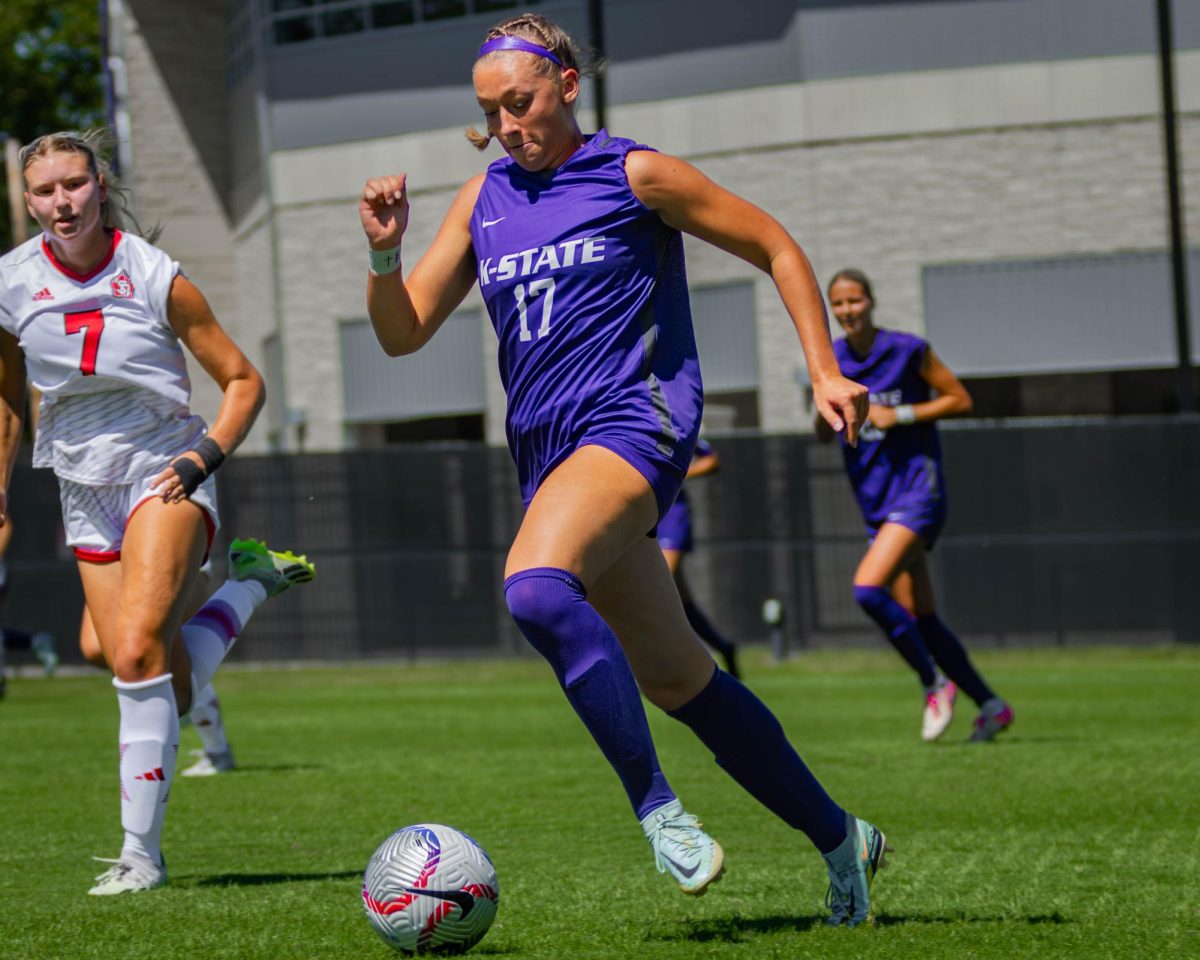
[816, 269, 1013, 740]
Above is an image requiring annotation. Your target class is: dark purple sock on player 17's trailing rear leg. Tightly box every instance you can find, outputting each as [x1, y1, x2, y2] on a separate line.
[667, 670, 846, 853]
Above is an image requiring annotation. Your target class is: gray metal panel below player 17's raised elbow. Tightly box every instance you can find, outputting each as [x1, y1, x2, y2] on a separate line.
[338, 310, 487, 424]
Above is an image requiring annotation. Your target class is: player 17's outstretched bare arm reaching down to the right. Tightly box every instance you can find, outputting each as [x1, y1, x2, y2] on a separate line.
[625, 150, 868, 443]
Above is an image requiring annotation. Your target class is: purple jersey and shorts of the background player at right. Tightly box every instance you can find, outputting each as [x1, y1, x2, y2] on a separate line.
[833, 330, 946, 527]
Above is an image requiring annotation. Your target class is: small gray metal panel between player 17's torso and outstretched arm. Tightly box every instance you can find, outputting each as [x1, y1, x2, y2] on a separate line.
[691, 282, 758, 392]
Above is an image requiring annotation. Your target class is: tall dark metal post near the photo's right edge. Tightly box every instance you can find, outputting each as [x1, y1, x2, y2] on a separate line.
[1157, 0, 1196, 413]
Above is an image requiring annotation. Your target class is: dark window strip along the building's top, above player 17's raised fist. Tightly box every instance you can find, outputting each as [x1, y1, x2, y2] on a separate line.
[262, 0, 541, 47]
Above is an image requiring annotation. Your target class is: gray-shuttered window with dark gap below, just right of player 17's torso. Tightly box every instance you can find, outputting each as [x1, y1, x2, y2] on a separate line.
[691, 281, 760, 433]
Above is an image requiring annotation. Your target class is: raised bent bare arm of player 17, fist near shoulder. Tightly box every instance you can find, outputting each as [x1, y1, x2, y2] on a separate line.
[359, 174, 484, 356]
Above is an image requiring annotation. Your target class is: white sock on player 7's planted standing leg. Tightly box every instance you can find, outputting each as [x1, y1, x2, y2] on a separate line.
[113, 673, 179, 864]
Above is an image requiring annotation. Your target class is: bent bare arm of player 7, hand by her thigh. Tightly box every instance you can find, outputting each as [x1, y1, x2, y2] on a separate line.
[154, 276, 266, 500]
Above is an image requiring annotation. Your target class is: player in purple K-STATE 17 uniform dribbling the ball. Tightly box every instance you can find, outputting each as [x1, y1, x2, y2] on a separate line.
[359, 14, 884, 924]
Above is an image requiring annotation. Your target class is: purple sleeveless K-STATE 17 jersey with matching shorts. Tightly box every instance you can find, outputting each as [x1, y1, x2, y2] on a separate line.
[470, 131, 703, 509]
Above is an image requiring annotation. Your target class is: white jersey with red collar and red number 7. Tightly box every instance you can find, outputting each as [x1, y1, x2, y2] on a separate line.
[0, 230, 205, 485]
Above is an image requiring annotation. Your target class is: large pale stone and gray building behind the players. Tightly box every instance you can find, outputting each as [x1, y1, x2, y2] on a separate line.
[107, 0, 1200, 451]
